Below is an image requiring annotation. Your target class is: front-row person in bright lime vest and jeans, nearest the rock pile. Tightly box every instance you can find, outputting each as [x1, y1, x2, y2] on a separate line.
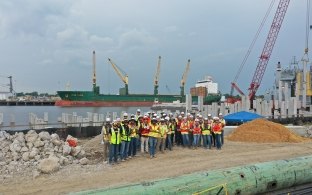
[108, 121, 121, 164]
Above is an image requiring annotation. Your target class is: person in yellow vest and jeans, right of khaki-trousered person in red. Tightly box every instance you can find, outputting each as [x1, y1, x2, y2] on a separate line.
[148, 118, 160, 158]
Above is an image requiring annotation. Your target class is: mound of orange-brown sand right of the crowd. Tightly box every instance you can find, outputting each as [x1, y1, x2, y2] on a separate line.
[227, 119, 307, 143]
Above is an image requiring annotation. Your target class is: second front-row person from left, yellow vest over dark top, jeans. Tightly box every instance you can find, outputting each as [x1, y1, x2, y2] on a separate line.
[120, 119, 131, 161]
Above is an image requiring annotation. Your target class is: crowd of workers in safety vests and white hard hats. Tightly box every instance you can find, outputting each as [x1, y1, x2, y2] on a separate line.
[102, 109, 225, 164]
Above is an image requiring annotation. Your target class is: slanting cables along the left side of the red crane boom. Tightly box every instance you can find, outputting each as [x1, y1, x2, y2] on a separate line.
[233, 0, 275, 83]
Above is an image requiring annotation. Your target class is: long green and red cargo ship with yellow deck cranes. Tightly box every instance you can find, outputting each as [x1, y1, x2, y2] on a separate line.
[55, 51, 218, 107]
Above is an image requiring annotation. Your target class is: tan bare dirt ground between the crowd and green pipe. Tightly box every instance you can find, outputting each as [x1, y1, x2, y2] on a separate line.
[0, 137, 312, 194]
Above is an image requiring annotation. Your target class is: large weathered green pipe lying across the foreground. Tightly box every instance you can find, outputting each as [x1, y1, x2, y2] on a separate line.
[74, 156, 312, 195]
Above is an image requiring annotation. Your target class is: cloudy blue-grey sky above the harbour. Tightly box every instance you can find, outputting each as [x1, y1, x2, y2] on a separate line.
[0, 0, 306, 94]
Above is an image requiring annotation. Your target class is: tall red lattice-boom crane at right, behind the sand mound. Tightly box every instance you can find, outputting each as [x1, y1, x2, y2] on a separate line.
[231, 0, 290, 108]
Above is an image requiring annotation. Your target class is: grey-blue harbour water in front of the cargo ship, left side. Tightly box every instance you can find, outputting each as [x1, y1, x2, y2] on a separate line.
[0, 106, 150, 126]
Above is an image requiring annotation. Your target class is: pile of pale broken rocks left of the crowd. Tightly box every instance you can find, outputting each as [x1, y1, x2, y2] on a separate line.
[0, 130, 88, 176]
